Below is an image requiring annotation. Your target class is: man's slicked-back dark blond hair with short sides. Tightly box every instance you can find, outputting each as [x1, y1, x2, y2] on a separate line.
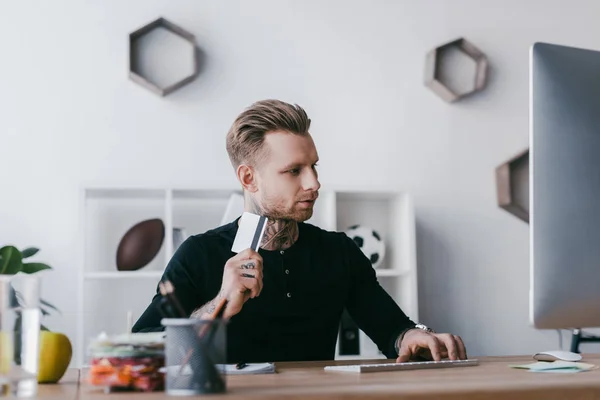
[227, 100, 310, 168]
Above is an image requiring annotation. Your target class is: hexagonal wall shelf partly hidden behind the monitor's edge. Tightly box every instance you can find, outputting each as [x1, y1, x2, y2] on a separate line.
[496, 149, 529, 223]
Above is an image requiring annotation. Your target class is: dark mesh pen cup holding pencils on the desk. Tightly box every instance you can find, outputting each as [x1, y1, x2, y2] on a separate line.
[161, 318, 227, 396]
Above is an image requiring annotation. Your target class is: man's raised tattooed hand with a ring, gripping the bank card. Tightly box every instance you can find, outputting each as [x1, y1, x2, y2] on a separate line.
[192, 249, 263, 318]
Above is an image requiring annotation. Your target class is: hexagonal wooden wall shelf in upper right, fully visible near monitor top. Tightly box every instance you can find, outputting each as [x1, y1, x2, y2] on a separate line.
[425, 38, 488, 102]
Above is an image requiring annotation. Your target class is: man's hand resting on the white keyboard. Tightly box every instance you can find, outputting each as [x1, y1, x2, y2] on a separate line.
[396, 328, 467, 363]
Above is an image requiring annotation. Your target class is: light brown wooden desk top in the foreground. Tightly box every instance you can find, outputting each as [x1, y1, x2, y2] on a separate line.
[74, 354, 600, 400]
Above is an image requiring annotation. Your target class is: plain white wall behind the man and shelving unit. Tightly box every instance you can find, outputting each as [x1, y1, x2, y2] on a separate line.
[0, 0, 600, 366]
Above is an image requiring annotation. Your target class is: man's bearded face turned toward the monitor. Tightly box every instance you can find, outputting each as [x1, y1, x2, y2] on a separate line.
[254, 131, 321, 222]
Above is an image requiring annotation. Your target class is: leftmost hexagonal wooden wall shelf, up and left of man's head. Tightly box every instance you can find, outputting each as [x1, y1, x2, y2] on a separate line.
[129, 18, 200, 96]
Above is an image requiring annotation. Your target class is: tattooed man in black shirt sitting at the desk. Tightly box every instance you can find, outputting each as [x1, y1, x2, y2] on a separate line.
[133, 100, 467, 362]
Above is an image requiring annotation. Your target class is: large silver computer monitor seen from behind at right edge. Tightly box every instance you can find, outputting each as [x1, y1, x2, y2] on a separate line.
[529, 43, 600, 329]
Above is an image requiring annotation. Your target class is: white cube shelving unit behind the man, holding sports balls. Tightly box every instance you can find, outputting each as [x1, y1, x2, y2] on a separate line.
[75, 187, 418, 366]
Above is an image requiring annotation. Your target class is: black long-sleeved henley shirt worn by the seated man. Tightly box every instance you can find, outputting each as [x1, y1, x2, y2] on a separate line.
[133, 220, 415, 362]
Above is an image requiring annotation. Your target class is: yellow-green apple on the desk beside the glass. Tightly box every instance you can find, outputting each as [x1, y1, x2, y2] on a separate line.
[38, 331, 73, 383]
